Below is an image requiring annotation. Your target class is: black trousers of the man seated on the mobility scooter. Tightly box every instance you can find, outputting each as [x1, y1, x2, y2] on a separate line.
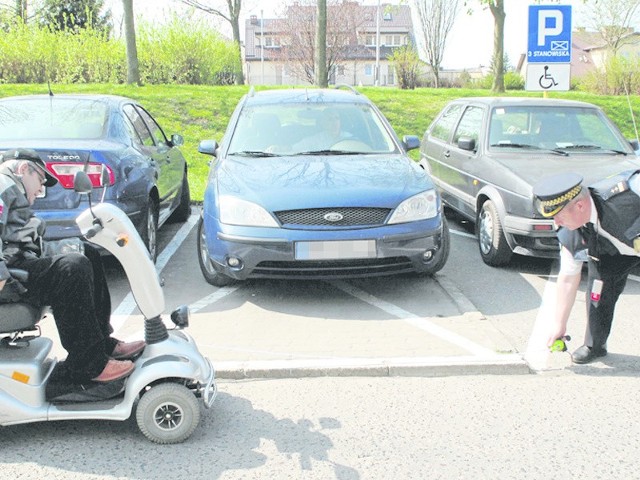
[12, 245, 117, 381]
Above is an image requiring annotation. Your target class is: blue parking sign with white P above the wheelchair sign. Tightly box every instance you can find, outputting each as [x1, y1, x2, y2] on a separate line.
[527, 5, 571, 63]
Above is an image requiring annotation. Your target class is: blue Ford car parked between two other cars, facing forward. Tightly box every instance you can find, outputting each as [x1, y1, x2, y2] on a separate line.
[198, 89, 449, 286]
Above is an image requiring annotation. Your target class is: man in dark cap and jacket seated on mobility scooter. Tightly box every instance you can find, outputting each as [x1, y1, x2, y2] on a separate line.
[0, 149, 145, 383]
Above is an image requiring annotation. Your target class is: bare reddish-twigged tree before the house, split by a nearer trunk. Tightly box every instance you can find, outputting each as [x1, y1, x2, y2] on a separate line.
[274, 0, 365, 84]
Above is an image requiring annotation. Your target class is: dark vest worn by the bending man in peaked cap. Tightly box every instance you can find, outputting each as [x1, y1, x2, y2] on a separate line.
[558, 170, 640, 255]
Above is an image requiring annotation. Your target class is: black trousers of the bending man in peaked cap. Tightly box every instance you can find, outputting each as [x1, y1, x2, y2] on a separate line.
[585, 255, 640, 348]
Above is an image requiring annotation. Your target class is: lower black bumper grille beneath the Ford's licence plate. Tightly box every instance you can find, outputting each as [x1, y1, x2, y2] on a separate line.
[251, 257, 415, 279]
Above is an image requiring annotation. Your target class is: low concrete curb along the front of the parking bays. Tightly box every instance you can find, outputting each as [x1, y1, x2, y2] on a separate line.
[214, 354, 533, 380]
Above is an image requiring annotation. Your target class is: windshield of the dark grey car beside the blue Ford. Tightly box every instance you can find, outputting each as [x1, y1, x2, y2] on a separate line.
[489, 106, 628, 153]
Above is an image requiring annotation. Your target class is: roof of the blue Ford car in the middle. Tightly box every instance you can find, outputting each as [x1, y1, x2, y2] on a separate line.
[244, 88, 371, 105]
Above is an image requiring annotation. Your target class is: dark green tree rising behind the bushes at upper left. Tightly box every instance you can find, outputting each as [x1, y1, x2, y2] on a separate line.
[39, 0, 111, 33]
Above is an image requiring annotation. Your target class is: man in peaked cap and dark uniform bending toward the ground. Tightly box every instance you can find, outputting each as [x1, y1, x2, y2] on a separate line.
[533, 170, 640, 363]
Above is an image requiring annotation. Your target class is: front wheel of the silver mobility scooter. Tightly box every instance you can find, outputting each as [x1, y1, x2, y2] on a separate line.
[136, 383, 200, 444]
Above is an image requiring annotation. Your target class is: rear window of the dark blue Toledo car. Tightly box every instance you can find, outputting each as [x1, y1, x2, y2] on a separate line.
[0, 97, 107, 140]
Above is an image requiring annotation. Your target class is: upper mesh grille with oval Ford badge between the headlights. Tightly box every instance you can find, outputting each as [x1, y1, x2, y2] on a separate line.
[275, 207, 390, 227]
